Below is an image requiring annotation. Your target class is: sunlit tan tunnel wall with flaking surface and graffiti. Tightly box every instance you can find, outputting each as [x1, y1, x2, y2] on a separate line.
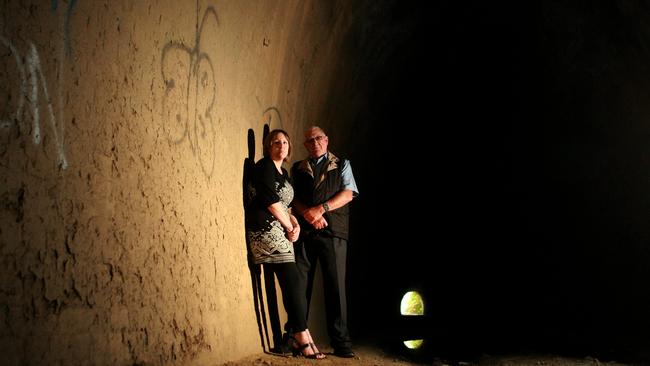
[0, 0, 362, 365]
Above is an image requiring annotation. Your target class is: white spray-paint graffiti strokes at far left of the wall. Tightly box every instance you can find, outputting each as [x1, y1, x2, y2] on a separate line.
[0, 36, 68, 169]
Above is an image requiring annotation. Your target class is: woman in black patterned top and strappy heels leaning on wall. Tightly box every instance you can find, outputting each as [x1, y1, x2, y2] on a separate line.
[246, 130, 325, 359]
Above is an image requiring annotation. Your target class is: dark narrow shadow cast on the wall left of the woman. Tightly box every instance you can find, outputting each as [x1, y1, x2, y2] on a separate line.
[242, 124, 282, 353]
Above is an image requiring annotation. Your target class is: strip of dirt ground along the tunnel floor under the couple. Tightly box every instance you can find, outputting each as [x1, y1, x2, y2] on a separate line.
[223, 346, 632, 366]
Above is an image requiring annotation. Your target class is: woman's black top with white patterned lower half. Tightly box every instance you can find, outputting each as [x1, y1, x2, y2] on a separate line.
[246, 157, 295, 264]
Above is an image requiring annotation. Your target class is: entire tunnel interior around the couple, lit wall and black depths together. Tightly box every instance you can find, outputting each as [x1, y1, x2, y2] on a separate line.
[0, 0, 650, 365]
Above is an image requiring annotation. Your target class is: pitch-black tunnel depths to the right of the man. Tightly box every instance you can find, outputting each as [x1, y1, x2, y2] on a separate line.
[348, 1, 650, 361]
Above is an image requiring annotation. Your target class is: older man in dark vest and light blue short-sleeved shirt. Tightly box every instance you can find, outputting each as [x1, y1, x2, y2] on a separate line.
[291, 126, 359, 358]
